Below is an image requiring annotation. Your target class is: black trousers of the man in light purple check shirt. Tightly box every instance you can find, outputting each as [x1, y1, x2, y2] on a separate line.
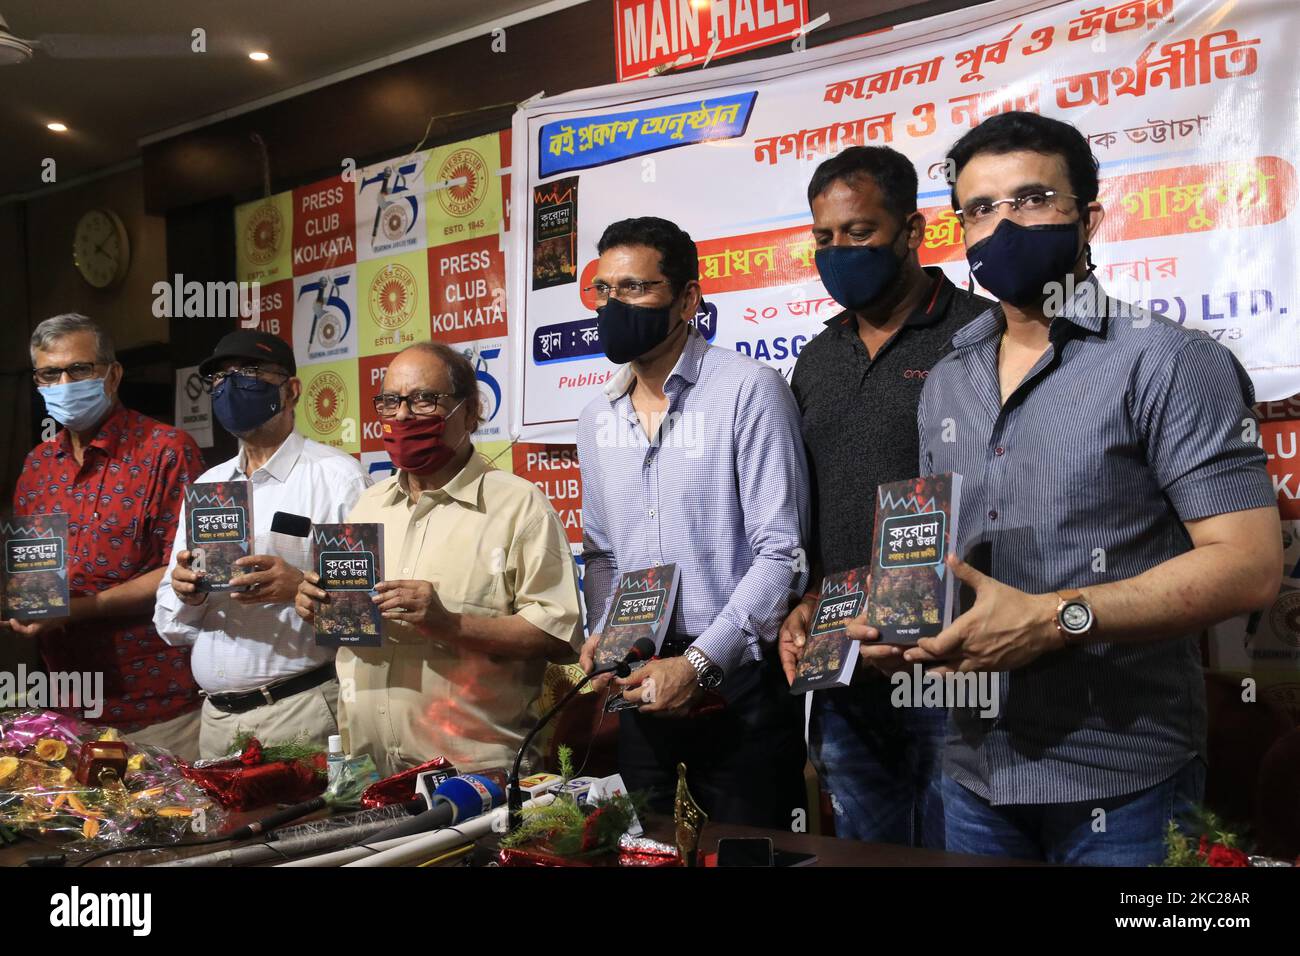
[619, 641, 807, 830]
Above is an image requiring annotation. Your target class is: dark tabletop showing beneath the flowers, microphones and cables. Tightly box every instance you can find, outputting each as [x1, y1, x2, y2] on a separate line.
[0, 809, 1036, 866]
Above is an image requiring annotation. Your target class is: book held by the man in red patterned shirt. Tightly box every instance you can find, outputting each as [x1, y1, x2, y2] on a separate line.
[0, 512, 70, 620]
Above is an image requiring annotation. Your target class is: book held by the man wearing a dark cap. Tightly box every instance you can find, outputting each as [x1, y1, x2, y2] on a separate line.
[185, 481, 252, 592]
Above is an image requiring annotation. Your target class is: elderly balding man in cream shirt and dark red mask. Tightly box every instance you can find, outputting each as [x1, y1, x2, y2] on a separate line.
[296, 342, 582, 775]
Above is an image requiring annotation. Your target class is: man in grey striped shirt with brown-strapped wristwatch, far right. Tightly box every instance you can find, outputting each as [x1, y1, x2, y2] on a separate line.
[904, 113, 1282, 865]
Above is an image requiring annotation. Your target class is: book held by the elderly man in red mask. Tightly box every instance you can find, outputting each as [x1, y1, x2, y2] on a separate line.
[311, 522, 384, 648]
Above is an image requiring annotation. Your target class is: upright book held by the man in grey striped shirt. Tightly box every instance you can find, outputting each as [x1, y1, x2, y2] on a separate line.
[867, 472, 962, 644]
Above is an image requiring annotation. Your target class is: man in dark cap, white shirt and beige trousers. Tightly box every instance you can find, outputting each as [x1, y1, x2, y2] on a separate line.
[153, 329, 369, 758]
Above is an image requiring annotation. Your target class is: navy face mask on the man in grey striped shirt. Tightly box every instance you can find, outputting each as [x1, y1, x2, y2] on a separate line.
[966, 219, 1080, 306]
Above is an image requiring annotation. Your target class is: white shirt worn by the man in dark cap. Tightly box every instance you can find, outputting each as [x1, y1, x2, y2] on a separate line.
[153, 432, 371, 693]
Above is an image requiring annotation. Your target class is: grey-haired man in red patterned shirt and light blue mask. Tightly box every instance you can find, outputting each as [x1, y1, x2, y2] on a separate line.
[5, 313, 203, 760]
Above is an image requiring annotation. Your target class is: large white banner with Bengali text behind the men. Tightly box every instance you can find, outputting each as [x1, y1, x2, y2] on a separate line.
[510, 0, 1300, 442]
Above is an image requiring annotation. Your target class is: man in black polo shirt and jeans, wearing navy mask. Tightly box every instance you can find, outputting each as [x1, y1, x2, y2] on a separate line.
[780, 146, 992, 849]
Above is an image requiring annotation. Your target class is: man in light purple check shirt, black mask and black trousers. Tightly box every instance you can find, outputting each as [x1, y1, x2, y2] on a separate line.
[577, 217, 809, 829]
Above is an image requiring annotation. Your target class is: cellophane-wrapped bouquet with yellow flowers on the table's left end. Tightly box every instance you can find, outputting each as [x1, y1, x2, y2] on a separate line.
[0, 709, 222, 849]
